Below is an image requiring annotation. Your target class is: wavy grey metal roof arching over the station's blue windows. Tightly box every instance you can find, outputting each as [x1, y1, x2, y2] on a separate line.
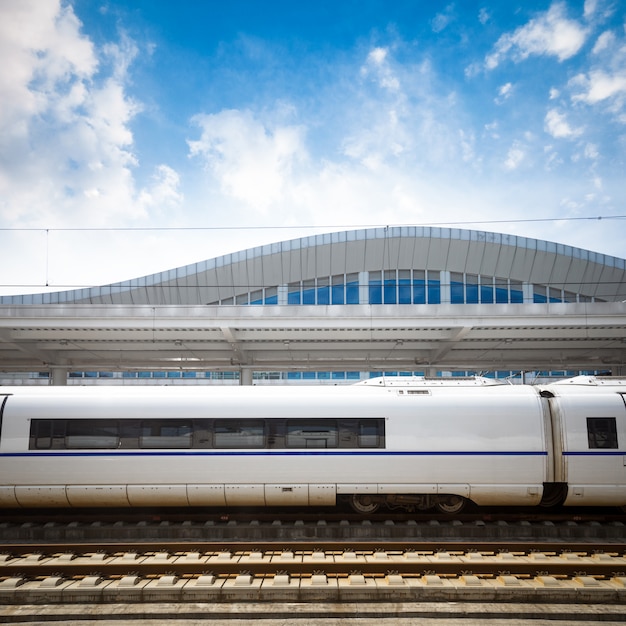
[0, 226, 626, 305]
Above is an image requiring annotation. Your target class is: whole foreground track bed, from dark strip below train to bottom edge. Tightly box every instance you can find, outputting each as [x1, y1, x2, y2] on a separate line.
[0, 519, 626, 623]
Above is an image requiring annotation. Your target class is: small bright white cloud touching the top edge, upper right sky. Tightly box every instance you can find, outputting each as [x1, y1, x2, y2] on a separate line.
[485, 2, 587, 69]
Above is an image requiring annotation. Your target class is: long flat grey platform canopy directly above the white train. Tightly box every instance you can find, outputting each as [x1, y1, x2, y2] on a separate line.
[0, 302, 626, 374]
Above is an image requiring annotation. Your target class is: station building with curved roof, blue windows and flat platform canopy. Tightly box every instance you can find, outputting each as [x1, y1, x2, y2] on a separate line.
[0, 227, 626, 384]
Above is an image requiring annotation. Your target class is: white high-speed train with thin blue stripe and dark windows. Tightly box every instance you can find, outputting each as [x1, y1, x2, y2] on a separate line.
[0, 377, 626, 514]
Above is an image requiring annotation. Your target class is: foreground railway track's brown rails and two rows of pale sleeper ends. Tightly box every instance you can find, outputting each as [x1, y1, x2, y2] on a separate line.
[0, 542, 626, 605]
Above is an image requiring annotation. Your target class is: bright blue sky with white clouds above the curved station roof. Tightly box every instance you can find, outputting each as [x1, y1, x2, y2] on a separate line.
[0, 0, 626, 294]
